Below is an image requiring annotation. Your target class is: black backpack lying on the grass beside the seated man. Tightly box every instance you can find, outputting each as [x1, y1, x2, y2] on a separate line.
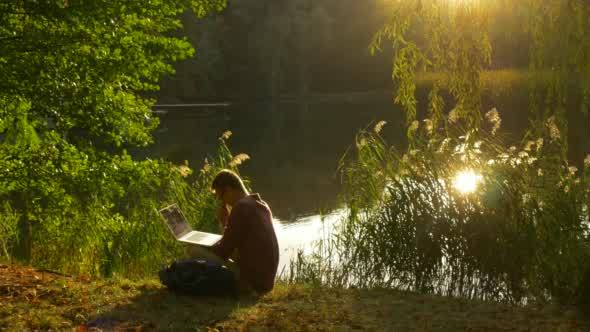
[159, 259, 237, 296]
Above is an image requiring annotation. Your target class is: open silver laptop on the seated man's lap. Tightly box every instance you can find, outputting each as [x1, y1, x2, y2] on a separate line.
[158, 204, 221, 247]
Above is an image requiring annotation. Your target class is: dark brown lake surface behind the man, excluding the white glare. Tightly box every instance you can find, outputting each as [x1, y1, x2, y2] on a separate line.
[147, 99, 405, 222]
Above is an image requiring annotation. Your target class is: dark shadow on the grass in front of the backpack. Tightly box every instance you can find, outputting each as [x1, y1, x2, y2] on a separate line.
[83, 288, 257, 331]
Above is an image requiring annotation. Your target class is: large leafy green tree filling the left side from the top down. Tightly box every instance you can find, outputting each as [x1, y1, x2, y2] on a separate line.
[0, 0, 225, 265]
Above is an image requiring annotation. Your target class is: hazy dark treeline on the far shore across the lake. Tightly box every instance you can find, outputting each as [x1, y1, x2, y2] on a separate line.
[158, 0, 530, 103]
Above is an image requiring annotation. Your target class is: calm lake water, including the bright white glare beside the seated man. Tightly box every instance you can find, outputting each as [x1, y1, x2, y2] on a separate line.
[147, 98, 590, 271]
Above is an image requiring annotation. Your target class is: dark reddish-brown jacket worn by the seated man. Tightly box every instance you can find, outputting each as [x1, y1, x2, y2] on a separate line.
[212, 194, 279, 293]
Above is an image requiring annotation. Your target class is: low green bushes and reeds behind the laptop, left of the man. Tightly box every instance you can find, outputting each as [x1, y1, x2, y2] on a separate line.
[0, 134, 247, 276]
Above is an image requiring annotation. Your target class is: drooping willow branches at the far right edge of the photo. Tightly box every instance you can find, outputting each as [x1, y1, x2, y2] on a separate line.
[527, 0, 590, 141]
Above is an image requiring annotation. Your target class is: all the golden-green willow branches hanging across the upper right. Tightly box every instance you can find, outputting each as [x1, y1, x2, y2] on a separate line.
[371, 0, 590, 145]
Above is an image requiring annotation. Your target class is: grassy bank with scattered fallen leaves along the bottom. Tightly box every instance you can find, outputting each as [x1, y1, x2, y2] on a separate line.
[0, 265, 590, 331]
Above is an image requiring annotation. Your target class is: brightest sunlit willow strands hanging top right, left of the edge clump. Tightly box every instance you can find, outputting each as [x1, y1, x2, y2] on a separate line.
[371, 0, 492, 132]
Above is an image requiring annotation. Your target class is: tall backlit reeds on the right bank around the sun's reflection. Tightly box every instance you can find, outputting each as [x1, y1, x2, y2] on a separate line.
[291, 113, 590, 303]
